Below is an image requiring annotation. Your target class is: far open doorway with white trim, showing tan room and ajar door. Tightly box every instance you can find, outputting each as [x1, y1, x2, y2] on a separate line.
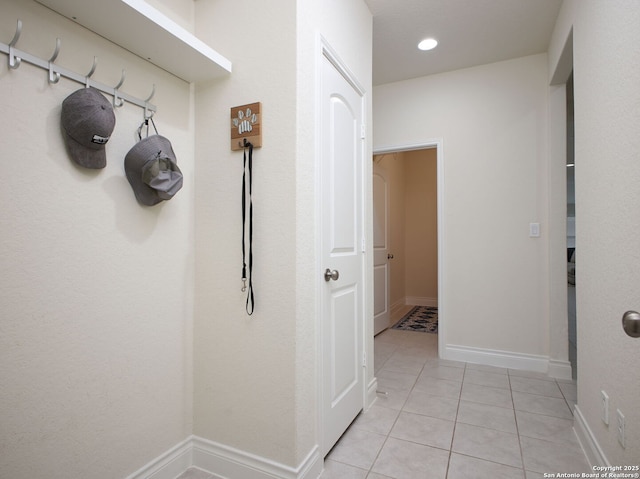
[373, 140, 446, 358]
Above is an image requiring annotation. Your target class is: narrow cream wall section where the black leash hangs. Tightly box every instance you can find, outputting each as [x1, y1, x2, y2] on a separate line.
[194, 1, 298, 464]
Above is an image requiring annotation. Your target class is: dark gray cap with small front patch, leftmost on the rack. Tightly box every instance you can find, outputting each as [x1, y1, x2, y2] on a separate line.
[61, 88, 116, 169]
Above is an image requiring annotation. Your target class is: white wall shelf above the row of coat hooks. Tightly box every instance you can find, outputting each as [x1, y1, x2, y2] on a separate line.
[36, 0, 231, 82]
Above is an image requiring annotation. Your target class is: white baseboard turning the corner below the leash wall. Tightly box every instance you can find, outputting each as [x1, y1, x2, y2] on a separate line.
[127, 438, 322, 479]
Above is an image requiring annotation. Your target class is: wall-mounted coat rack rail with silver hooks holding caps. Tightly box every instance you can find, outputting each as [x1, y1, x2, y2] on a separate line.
[0, 20, 156, 118]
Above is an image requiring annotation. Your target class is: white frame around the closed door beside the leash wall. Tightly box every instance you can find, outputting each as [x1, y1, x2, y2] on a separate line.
[314, 34, 370, 459]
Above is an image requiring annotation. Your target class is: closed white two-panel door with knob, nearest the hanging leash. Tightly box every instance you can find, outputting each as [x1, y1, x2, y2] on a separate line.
[318, 52, 364, 455]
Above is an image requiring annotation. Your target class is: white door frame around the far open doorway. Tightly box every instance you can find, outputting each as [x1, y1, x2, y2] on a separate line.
[368, 138, 447, 357]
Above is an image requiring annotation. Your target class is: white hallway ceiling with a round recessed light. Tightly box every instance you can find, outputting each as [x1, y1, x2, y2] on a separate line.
[365, 0, 562, 85]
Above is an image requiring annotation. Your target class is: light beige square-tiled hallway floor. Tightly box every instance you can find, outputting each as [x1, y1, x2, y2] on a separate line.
[321, 311, 590, 479]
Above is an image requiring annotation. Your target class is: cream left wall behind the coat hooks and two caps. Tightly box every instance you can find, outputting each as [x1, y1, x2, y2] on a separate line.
[0, 0, 194, 479]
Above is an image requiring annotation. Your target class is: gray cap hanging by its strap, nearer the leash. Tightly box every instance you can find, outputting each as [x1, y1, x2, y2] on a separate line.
[124, 135, 182, 206]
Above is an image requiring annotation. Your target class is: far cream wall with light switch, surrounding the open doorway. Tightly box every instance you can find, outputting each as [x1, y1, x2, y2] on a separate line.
[374, 54, 549, 356]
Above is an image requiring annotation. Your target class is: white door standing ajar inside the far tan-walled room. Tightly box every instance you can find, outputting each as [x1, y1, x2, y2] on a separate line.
[373, 164, 390, 335]
